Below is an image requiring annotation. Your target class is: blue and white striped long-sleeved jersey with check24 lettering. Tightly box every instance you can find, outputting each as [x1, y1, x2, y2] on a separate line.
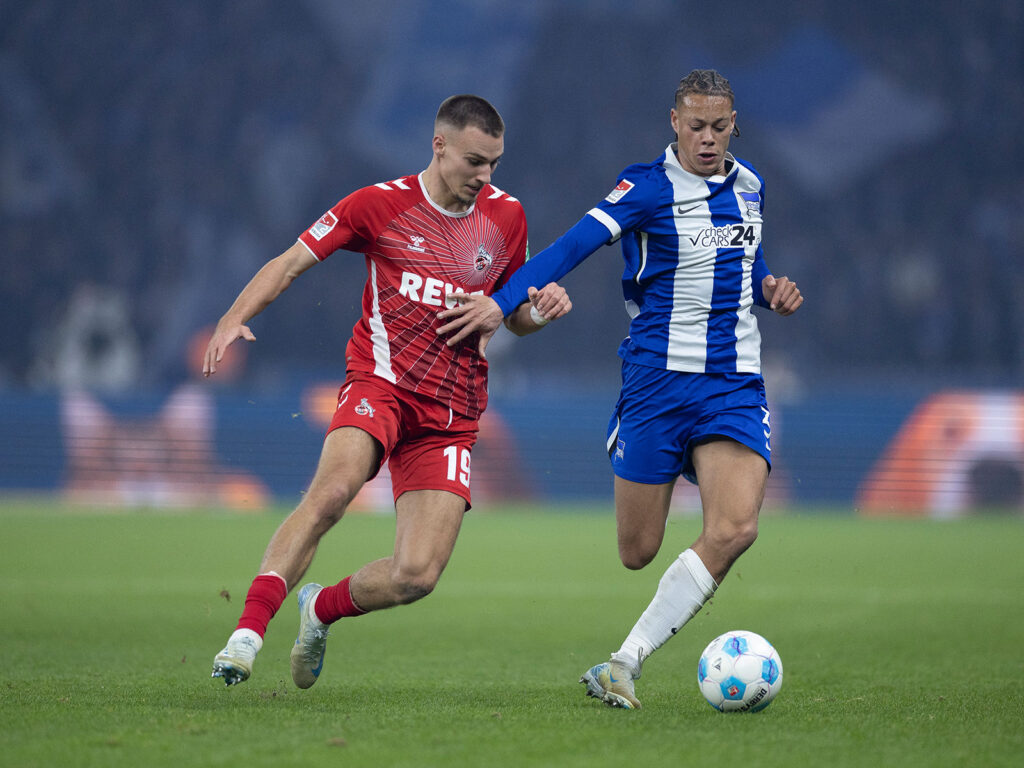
[493, 145, 769, 374]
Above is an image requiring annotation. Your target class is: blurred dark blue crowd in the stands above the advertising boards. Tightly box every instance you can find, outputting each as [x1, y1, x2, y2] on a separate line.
[0, 0, 1024, 391]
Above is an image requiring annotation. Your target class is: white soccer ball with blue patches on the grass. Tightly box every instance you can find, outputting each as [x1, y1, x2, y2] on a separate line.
[697, 630, 782, 712]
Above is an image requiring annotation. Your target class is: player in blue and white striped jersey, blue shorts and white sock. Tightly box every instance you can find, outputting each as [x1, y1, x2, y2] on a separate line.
[437, 70, 804, 709]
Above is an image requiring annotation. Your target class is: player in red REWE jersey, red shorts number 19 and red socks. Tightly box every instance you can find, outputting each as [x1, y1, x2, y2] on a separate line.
[204, 95, 571, 688]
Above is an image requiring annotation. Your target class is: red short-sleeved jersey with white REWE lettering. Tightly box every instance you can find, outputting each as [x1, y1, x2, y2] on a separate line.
[299, 175, 526, 419]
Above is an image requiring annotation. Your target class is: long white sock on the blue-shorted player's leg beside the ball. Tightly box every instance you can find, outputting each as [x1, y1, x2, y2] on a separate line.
[611, 549, 718, 678]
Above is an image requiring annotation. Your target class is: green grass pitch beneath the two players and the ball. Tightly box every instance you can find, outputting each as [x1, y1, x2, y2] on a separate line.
[0, 504, 1024, 768]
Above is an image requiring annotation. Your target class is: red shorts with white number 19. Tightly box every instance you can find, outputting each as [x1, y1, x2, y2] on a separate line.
[327, 373, 479, 509]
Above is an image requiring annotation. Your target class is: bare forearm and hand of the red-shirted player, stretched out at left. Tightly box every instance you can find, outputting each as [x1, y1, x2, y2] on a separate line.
[203, 242, 316, 376]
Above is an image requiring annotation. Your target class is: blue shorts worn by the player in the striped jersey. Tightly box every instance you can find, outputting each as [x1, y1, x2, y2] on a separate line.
[608, 362, 771, 484]
